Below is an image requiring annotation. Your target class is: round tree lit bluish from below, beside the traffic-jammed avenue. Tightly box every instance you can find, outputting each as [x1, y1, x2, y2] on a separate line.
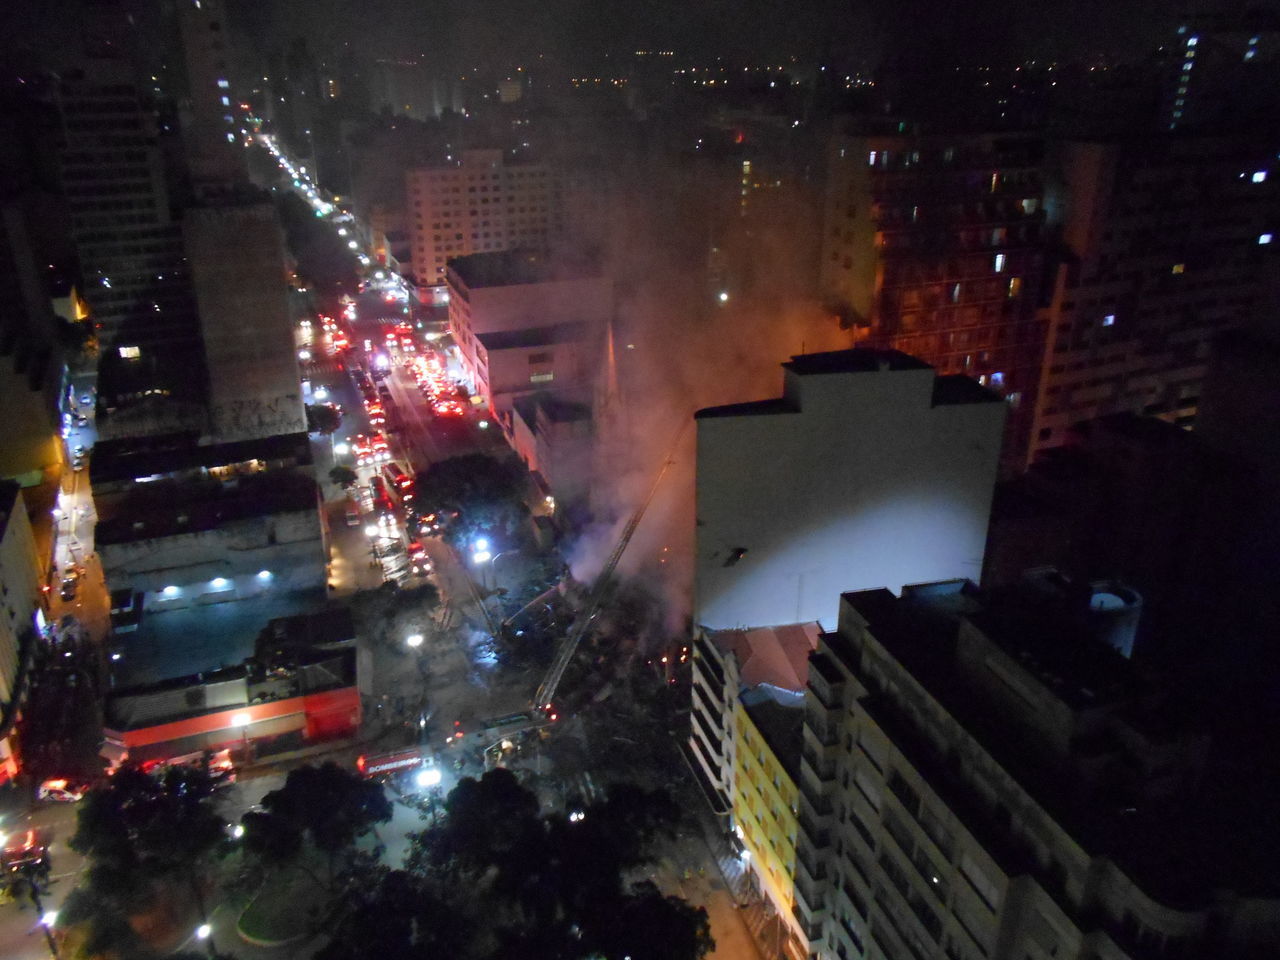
[417, 453, 529, 545]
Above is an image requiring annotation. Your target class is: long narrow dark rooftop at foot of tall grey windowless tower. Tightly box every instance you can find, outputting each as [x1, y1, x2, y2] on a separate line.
[90, 433, 311, 484]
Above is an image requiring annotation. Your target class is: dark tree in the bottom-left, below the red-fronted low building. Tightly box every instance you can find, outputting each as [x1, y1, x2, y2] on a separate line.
[63, 765, 227, 952]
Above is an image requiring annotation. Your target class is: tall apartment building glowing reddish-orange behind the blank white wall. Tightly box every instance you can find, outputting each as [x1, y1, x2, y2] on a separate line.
[819, 123, 1044, 463]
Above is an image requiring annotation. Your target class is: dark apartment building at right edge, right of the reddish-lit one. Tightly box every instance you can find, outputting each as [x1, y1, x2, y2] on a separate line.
[1028, 134, 1280, 458]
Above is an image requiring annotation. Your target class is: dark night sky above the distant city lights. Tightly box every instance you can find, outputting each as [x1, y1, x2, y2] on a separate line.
[10, 0, 1280, 77]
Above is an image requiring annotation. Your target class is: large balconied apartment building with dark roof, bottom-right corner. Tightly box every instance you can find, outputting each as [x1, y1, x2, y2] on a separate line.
[795, 582, 1280, 960]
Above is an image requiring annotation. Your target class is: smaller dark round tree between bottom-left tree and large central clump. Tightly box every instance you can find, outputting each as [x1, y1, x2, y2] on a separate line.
[242, 762, 392, 890]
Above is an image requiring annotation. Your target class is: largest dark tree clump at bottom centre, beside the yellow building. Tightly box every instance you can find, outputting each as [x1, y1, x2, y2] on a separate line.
[317, 769, 714, 960]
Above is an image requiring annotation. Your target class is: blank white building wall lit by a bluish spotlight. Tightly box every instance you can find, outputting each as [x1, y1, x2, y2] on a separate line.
[695, 358, 1005, 630]
